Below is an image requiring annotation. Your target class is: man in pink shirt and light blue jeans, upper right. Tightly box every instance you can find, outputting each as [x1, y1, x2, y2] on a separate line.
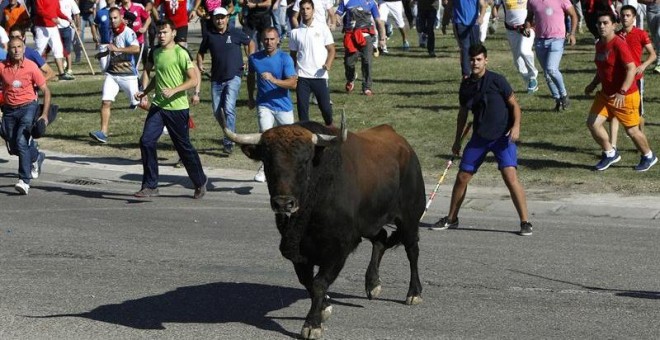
[523, 0, 578, 112]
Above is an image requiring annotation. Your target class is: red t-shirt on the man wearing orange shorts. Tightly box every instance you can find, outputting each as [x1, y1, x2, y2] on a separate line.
[594, 36, 637, 96]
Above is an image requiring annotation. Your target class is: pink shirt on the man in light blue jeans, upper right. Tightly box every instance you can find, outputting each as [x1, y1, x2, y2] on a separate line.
[527, 0, 573, 39]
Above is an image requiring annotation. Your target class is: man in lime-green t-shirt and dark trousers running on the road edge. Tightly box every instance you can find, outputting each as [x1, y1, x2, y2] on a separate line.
[135, 19, 208, 198]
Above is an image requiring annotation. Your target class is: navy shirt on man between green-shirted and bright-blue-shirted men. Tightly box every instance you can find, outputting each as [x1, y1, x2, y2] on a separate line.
[198, 28, 250, 82]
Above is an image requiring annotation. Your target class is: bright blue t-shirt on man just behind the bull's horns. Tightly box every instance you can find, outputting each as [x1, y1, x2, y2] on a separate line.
[249, 50, 296, 111]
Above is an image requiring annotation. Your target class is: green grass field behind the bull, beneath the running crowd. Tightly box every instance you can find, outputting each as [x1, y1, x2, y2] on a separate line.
[40, 29, 660, 194]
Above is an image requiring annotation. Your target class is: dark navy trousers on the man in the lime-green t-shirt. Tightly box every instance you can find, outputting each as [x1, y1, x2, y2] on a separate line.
[140, 105, 206, 189]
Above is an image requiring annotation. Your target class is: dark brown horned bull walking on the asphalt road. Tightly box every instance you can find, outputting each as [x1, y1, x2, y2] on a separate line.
[224, 115, 426, 339]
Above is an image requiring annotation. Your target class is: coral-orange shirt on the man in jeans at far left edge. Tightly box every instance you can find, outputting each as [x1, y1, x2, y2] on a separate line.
[0, 59, 46, 106]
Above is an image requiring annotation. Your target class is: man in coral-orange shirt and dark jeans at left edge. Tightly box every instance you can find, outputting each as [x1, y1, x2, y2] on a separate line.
[0, 38, 50, 195]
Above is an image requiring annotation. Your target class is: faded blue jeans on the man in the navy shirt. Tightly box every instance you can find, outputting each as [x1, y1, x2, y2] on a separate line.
[211, 76, 241, 147]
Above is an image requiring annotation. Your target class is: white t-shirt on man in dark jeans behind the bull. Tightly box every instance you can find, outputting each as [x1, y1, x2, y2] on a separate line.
[289, 19, 335, 79]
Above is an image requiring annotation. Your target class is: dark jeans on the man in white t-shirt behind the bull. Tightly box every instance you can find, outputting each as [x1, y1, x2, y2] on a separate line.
[296, 78, 332, 125]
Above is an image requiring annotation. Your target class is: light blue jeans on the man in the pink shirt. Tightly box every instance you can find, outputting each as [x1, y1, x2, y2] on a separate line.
[534, 38, 567, 99]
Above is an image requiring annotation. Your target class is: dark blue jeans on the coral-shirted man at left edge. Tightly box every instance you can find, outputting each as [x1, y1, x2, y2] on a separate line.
[2, 101, 39, 184]
